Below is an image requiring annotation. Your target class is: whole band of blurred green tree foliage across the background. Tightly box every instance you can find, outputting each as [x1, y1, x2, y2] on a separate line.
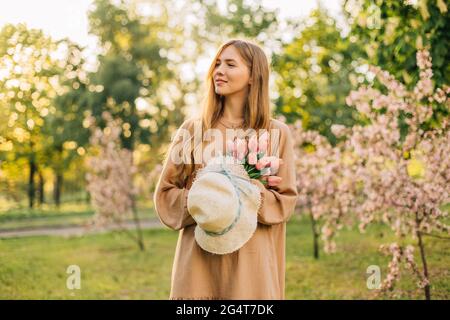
[0, 0, 450, 222]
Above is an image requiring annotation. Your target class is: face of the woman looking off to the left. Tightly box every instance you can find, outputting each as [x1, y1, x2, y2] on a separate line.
[213, 45, 250, 96]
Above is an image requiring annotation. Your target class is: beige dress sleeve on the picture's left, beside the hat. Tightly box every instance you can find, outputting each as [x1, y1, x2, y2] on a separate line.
[153, 121, 195, 230]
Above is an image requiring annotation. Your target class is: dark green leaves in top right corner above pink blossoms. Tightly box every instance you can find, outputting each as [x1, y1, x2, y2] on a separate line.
[344, 0, 450, 89]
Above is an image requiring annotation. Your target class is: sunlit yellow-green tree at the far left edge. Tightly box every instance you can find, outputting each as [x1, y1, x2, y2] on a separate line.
[0, 24, 60, 208]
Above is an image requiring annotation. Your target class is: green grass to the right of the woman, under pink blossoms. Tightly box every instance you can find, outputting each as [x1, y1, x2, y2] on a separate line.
[286, 216, 450, 299]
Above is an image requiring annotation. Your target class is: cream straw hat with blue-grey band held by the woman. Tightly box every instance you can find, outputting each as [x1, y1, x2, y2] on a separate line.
[187, 156, 261, 254]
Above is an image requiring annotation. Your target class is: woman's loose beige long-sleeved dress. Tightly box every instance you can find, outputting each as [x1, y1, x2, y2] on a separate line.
[154, 119, 297, 300]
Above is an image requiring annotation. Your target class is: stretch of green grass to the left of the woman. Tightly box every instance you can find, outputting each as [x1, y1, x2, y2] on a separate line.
[0, 230, 176, 299]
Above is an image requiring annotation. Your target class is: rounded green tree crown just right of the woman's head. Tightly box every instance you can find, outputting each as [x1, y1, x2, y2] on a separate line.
[273, 7, 362, 142]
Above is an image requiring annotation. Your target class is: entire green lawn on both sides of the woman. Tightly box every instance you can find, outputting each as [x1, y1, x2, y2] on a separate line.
[0, 216, 450, 299]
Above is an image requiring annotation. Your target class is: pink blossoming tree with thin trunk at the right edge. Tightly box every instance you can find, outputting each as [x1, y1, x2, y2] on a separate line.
[333, 50, 450, 300]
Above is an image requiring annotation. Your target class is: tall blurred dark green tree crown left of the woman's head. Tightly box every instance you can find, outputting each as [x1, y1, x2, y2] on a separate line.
[88, 0, 174, 149]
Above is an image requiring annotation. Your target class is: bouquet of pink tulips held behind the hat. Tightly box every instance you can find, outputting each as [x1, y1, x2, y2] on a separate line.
[227, 131, 283, 186]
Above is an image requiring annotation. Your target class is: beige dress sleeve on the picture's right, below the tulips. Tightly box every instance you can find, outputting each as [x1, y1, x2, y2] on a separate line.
[252, 124, 298, 225]
